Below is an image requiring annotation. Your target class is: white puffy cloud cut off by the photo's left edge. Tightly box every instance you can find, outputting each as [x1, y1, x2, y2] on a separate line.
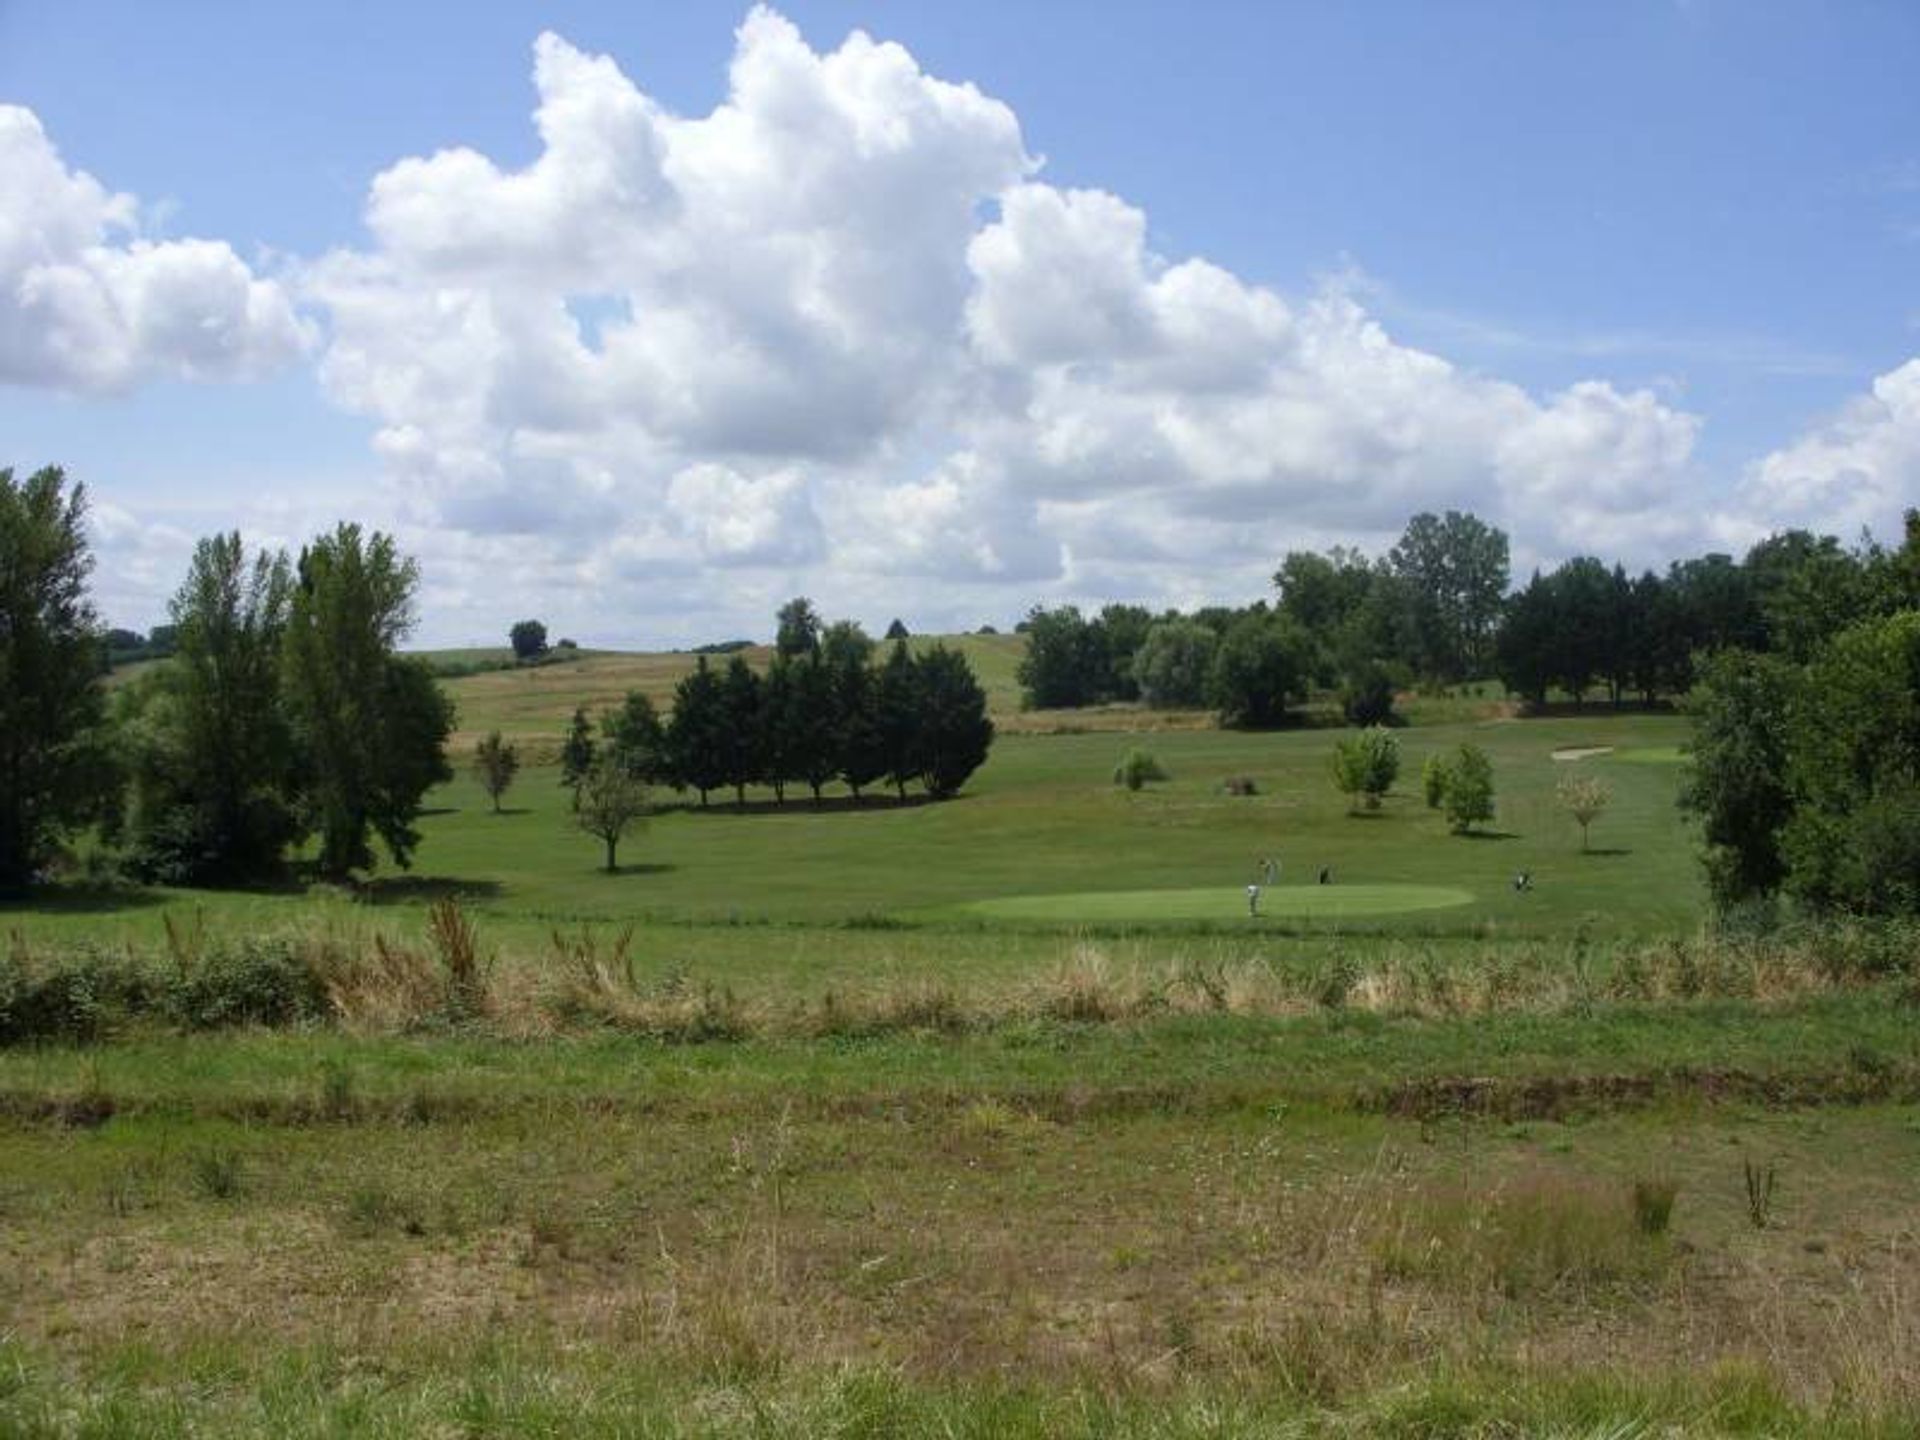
[0, 106, 307, 392]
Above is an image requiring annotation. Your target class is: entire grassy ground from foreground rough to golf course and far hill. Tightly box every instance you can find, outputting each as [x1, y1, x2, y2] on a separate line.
[15, 672, 1920, 1436]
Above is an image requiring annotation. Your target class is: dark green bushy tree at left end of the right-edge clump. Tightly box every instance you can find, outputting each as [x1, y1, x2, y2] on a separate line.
[1680, 649, 1799, 910]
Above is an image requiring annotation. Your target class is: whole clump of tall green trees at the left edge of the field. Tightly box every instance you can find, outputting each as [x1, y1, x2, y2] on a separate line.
[0, 468, 453, 885]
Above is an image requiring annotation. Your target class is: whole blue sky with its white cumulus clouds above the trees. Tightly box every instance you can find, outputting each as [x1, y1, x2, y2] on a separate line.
[0, 0, 1920, 643]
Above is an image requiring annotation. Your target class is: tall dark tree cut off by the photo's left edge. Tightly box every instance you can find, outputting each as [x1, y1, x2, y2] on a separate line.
[0, 467, 115, 887]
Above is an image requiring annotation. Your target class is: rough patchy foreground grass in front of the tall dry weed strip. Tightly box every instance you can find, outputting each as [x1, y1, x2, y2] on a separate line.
[0, 995, 1920, 1434]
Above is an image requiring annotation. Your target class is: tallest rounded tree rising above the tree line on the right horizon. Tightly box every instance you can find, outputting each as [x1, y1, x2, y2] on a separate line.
[1388, 511, 1507, 680]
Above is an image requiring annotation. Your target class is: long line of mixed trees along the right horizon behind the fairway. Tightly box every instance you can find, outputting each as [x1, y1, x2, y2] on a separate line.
[1020, 511, 1910, 726]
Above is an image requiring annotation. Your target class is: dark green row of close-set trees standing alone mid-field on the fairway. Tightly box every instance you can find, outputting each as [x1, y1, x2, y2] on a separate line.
[561, 599, 993, 806]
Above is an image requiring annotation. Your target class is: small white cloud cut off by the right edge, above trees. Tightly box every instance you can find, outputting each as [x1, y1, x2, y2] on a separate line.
[1724, 359, 1920, 540]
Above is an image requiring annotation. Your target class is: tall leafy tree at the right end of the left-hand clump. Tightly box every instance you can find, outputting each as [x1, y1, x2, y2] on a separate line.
[282, 524, 453, 879]
